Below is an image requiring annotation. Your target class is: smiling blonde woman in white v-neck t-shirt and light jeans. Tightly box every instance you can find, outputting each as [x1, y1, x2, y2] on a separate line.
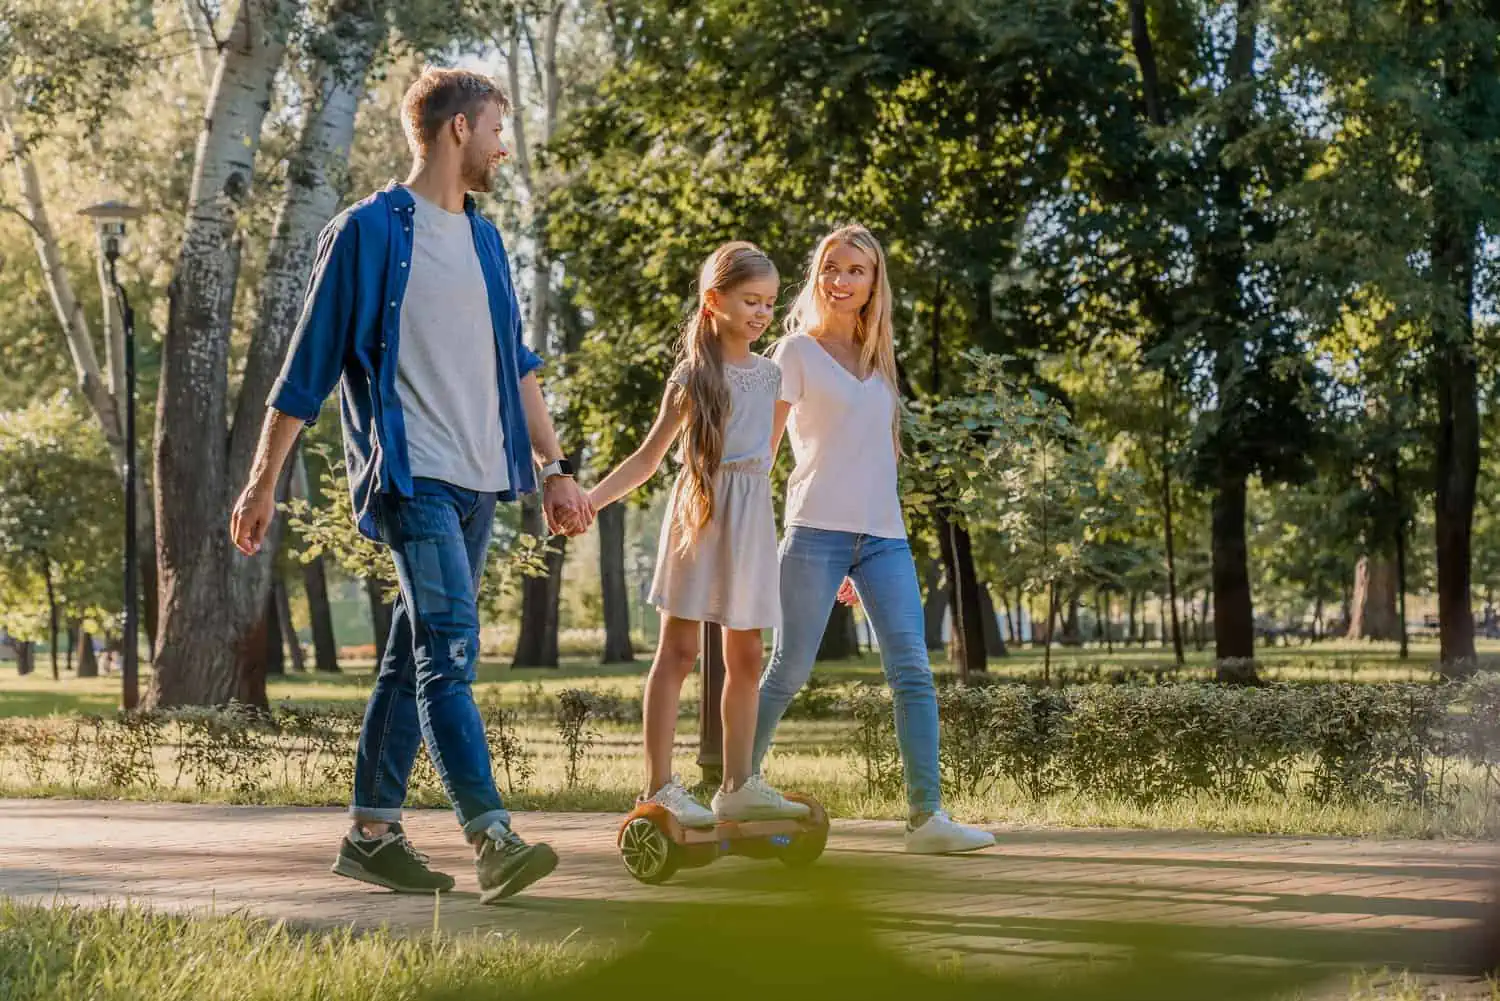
[752, 227, 995, 854]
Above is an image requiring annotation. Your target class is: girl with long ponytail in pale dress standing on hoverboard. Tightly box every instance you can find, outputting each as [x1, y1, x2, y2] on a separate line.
[590, 242, 809, 827]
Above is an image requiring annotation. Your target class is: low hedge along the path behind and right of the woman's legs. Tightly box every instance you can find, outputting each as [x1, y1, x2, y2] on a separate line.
[851, 677, 1500, 809]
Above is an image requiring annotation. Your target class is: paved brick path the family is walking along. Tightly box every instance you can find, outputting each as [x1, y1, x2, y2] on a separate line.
[0, 800, 1496, 996]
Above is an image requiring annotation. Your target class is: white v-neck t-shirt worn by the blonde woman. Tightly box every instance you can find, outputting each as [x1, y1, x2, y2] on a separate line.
[771, 333, 906, 539]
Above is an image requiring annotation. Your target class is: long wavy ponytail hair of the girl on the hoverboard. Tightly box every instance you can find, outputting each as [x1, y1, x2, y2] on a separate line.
[674, 240, 777, 549]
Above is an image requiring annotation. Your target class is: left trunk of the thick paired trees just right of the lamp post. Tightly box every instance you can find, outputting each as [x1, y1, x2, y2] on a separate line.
[144, 0, 293, 708]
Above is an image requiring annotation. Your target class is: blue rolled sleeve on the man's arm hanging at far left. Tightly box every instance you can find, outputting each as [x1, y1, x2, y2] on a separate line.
[266, 216, 359, 425]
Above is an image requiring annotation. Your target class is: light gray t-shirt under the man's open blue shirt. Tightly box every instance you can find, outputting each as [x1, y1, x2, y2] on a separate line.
[396, 192, 510, 492]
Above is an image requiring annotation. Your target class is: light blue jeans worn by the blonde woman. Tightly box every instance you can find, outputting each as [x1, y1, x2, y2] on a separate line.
[753, 525, 942, 813]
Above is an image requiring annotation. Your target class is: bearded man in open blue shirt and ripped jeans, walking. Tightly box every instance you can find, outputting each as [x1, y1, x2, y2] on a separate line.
[231, 69, 594, 903]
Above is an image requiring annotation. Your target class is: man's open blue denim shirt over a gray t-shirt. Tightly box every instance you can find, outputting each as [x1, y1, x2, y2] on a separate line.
[266, 183, 542, 539]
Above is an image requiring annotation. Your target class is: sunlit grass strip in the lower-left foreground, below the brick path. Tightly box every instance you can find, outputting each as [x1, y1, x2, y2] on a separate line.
[0, 897, 590, 1001]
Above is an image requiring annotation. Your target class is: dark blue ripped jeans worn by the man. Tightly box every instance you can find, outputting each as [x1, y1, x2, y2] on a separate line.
[350, 479, 510, 834]
